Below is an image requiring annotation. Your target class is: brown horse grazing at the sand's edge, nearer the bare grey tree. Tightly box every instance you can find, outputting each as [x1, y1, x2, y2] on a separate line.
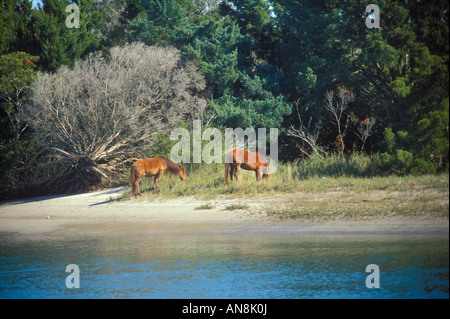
[131, 155, 187, 196]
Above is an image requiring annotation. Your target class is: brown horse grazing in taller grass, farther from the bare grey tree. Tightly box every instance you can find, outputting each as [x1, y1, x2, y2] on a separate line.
[224, 148, 270, 184]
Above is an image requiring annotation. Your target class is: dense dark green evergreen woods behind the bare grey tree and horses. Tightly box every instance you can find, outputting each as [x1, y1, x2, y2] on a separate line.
[0, 0, 449, 198]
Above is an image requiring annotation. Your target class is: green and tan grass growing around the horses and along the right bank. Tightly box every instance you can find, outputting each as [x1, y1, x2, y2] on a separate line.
[121, 162, 449, 221]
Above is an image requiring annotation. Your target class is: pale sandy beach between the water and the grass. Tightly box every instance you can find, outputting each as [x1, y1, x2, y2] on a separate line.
[0, 188, 449, 237]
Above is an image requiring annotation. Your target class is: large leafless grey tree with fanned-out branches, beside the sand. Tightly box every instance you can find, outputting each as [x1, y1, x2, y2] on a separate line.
[21, 43, 206, 193]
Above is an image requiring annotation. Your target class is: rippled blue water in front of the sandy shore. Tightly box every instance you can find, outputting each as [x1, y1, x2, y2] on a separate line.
[0, 234, 449, 299]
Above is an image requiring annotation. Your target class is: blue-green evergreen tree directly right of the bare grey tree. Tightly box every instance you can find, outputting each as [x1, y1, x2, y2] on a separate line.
[183, 18, 291, 128]
